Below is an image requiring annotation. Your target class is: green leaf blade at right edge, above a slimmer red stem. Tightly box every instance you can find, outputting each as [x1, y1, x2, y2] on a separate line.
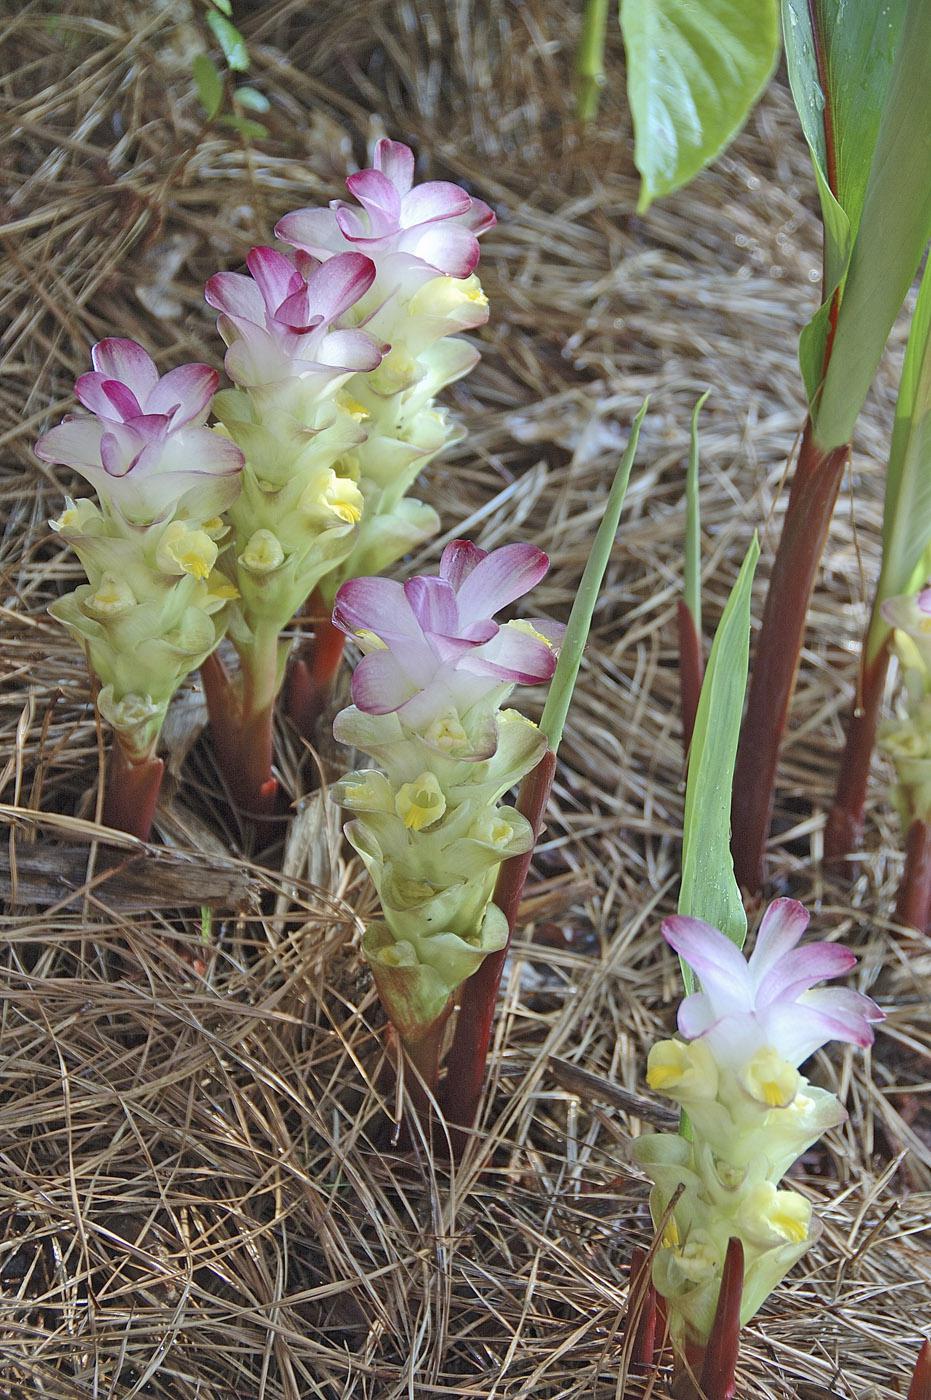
[867, 260, 931, 662]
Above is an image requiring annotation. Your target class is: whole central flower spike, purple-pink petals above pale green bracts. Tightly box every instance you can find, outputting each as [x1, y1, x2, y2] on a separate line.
[333, 540, 560, 1040]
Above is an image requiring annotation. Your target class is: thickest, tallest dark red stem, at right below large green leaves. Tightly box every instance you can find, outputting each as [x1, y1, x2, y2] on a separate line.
[732, 420, 848, 893]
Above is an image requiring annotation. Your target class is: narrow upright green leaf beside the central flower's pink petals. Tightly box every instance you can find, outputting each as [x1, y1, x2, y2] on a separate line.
[540, 399, 650, 752]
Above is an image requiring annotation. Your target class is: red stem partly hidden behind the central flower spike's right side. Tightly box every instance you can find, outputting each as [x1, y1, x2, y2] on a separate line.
[444, 749, 556, 1154]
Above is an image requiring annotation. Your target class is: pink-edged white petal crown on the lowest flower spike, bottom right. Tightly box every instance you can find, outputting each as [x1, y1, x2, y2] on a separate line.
[662, 899, 883, 1068]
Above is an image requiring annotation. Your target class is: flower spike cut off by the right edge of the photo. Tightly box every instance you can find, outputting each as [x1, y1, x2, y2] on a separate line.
[879, 585, 931, 827]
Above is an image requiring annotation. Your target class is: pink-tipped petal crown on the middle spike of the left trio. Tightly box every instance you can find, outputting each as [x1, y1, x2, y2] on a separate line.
[204, 248, 386, 388]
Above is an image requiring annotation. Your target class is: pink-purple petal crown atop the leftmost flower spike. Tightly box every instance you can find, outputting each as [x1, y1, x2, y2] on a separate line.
[35, 339, 242, 524]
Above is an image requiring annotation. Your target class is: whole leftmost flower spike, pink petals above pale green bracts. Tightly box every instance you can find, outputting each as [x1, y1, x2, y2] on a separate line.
[35, 340, 242, 762]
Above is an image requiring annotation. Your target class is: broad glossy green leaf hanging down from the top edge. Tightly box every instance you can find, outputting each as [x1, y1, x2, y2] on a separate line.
[620, 0, 780, 211]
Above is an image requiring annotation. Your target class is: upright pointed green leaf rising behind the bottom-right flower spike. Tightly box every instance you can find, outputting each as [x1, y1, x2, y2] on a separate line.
[679, 536, 760, 991]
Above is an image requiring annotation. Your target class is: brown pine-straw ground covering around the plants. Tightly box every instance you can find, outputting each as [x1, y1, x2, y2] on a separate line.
[0, 0, 931, 1400]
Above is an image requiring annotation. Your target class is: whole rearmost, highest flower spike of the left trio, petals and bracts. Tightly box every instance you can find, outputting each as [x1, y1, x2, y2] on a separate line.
[276, 140, 494, 602]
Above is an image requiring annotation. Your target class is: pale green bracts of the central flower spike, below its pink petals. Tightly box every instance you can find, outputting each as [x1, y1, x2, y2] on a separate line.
[333, 705, 546, 1040]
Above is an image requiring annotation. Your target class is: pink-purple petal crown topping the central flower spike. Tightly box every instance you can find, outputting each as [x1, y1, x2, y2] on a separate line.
[333, 539, 563, 727]
